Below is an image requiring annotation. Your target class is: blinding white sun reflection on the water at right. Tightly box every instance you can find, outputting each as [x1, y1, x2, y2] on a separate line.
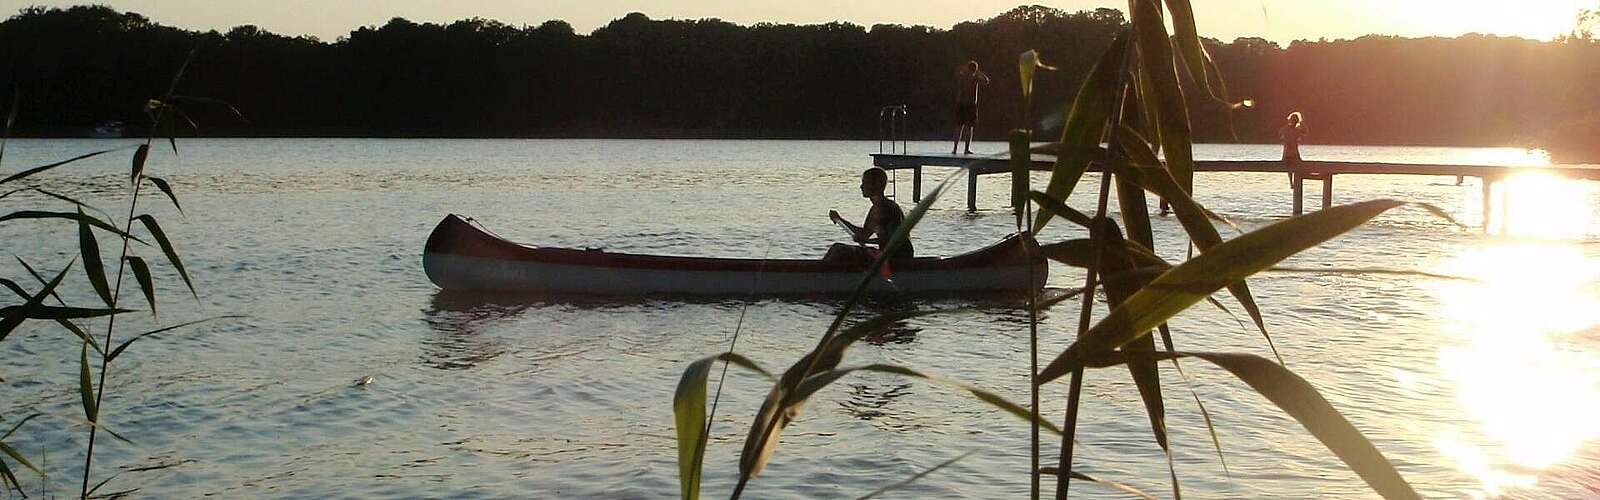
[1434, 241, 1600, 497]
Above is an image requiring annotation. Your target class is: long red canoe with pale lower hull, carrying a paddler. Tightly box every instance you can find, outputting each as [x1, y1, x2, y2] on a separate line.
[422, 215, 1048, 295]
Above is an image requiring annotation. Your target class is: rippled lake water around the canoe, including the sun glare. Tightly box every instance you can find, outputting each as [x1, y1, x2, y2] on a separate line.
[0, 139, 1600, 498]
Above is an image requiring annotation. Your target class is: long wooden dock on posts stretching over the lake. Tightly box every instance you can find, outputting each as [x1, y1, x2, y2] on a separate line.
[872, 154, 1600, 228]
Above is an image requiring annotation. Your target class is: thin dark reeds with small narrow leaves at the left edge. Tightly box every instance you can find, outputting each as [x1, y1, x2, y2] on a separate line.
[0, 51, 237, 498]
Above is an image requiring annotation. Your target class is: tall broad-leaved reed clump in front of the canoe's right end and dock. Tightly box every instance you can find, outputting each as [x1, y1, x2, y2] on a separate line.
[674, 0, 1448, 498]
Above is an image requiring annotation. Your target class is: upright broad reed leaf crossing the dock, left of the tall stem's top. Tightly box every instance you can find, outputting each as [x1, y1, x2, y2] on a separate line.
[1030, 32, 1130, 234]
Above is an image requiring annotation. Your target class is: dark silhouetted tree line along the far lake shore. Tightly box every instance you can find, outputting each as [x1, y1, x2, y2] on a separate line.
[0, 6, 1600, 144]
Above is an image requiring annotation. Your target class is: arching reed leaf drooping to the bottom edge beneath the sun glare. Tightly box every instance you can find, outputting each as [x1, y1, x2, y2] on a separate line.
[1088, 353, 1421, 498]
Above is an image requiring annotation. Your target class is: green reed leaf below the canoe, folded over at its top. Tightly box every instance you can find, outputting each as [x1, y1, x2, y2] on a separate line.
[672, 353, 773, 500]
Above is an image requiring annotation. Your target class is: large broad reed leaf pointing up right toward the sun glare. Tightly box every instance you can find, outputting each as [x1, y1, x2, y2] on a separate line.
[1040, 200, 1406, 383]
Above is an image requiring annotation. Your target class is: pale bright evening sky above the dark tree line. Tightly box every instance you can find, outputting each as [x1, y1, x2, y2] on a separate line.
[0, 0, 1600, 42]
